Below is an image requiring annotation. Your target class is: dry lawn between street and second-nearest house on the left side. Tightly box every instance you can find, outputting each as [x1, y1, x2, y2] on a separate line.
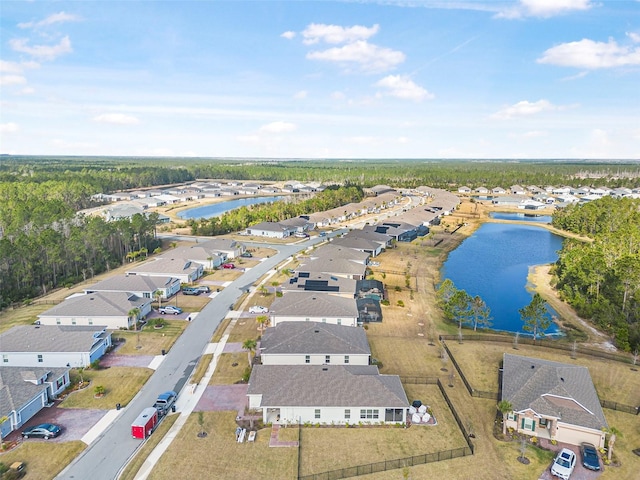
[113, 319, 189, 355]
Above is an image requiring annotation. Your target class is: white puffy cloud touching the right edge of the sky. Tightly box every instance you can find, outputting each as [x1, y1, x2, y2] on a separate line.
[537, 38, 640, 69]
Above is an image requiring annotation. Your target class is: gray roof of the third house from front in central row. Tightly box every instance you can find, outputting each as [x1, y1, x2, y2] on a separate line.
[271, 292, 358, 318]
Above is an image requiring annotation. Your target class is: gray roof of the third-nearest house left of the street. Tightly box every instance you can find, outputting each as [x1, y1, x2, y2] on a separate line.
[38, 292, 151, 317]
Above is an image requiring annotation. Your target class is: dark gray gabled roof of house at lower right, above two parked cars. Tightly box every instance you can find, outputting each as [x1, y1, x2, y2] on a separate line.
[502, 353, 607, 430]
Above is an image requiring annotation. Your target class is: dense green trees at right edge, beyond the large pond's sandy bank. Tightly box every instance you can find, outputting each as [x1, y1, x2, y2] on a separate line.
[553, 197, 640, 351]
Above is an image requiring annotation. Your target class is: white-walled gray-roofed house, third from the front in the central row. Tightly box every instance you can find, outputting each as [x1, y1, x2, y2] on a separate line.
[269, 292, 359, 327]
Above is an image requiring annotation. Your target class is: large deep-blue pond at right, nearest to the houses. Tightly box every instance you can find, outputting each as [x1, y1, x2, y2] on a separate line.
[441, 223, 562, 335]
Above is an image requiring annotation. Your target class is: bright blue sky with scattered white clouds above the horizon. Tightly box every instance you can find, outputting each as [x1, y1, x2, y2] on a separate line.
[0, 0, 640, 159]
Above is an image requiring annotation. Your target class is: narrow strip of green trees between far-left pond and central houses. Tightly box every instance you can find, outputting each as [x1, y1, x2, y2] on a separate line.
[187, 186, 364, 235]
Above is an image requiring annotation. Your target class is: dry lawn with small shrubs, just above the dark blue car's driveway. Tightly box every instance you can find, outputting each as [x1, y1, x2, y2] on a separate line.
[60, 367, 153, 409]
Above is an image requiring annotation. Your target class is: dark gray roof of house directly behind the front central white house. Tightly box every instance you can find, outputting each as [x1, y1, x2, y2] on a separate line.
[260, 322, 371, 355]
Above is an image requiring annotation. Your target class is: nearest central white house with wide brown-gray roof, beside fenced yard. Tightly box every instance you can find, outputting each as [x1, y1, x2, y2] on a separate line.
[247, 365, 409, 425]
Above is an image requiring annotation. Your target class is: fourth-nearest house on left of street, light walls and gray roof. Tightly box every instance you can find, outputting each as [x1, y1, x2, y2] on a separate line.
[84, 275, 180, 299]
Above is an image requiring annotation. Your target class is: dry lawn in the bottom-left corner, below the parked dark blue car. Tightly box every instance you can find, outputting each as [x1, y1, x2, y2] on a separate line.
[0, 440, 86, 480]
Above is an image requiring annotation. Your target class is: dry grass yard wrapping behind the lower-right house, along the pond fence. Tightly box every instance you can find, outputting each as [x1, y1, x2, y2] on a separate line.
[447, 341, 640, 406]
